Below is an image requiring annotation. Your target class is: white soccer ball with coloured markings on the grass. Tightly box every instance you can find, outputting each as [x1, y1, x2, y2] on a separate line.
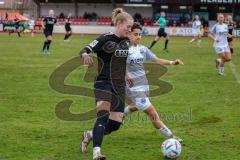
[161, 138, 182, 159]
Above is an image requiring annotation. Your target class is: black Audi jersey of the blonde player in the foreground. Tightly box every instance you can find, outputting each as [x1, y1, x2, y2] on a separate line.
[86, 33, 129, 86]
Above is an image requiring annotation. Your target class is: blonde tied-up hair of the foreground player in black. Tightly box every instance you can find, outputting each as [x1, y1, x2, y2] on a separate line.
[112, 8, 133, 25]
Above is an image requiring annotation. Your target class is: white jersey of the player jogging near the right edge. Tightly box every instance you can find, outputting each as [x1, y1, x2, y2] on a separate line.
[211, 23, 228, 47]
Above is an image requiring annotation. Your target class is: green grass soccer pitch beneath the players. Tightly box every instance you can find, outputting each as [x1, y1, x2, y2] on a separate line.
[0, 34, 240, 160]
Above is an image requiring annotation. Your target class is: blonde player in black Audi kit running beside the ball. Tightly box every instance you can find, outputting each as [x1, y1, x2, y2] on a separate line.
[80, 8, 133, 160]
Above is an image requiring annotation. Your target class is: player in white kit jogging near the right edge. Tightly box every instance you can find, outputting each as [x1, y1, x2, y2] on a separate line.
[209, 13, 232, 75]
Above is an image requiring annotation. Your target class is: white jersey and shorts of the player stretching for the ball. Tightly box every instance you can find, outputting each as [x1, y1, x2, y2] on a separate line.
[126, 44, 156, 110]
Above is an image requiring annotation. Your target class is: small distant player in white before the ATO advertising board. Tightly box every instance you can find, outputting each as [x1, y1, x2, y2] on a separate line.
[189, 15, 202, 47]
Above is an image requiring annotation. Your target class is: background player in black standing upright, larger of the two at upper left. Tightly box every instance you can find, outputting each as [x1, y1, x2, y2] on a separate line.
[42, 10, 57, 54]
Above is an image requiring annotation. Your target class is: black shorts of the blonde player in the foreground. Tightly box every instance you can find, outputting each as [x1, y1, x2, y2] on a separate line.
[94, 81, 125, 113]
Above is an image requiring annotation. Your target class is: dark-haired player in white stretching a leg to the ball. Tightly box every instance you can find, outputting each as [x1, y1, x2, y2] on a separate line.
[124, 23, 183, 142]
